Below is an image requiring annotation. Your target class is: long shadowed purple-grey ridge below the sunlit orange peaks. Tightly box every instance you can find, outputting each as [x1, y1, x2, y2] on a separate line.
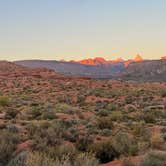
[15, 60, 125, 78]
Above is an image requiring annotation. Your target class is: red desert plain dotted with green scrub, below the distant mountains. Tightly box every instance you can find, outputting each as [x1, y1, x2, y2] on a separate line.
[0, 65, 166, 166]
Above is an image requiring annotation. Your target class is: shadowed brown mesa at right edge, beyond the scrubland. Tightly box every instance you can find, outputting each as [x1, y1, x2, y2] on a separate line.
[116, 59, 166, 81]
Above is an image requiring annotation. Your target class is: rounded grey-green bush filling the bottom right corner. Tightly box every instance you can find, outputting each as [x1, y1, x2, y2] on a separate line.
[140, 151, 166, 166]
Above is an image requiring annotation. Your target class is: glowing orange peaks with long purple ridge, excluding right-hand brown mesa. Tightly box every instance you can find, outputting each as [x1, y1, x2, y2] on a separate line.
[15, 55, 143, 79]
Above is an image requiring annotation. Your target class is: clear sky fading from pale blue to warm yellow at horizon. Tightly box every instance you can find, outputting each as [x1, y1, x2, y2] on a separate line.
[0, 0, 166, 61]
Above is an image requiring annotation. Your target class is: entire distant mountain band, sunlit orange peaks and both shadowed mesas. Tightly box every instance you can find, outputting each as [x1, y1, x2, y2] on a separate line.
[15, 55, 166, 81]
